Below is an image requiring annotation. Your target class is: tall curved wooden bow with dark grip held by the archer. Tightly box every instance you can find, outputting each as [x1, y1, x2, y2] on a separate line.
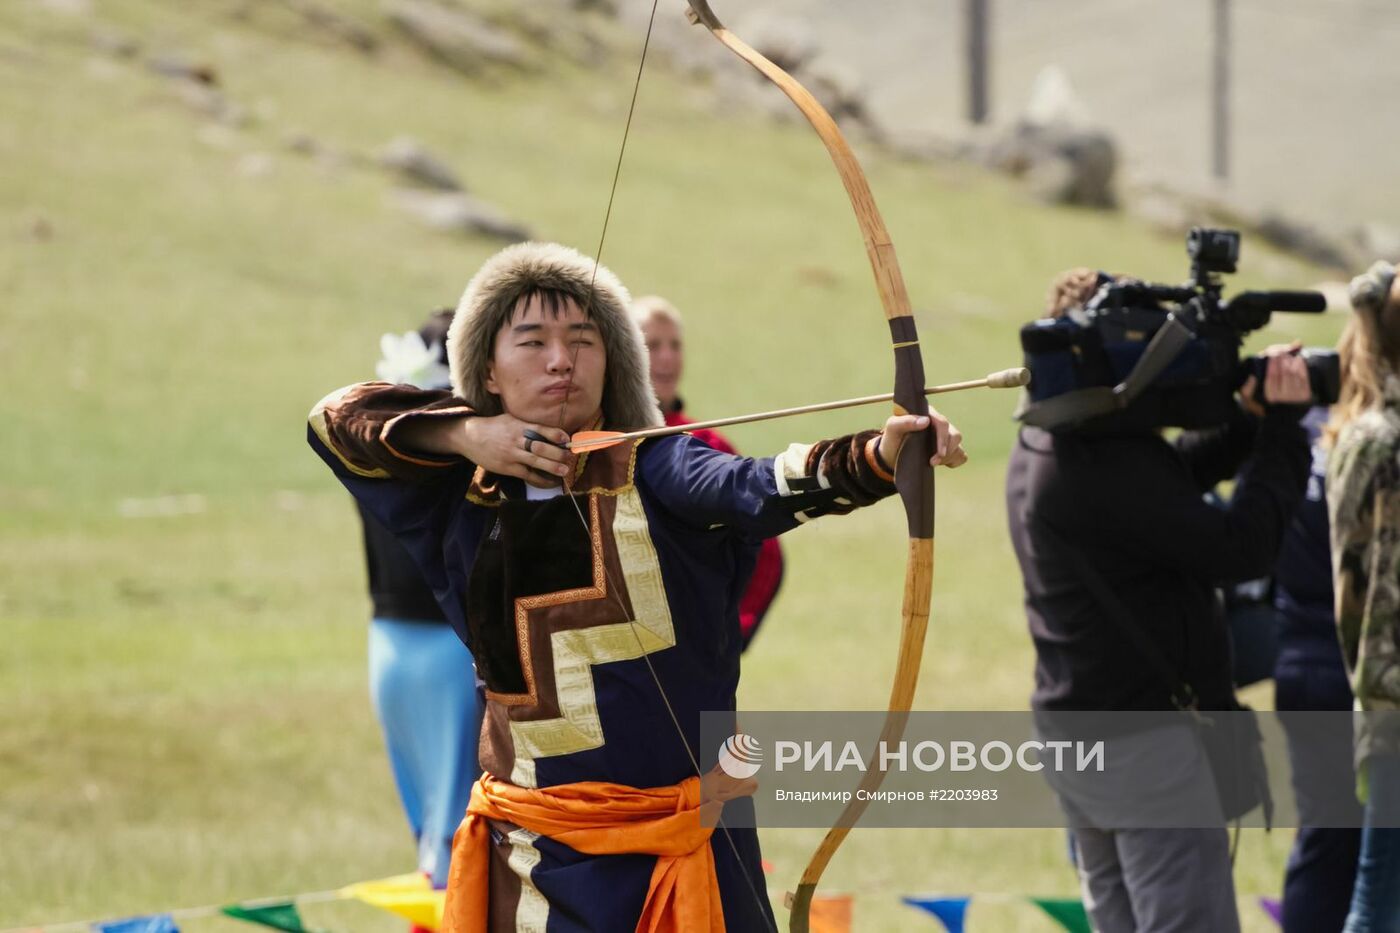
[687, 0, 934, 932]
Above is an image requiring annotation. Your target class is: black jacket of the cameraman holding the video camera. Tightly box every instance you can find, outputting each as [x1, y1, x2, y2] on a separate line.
[1007, 409, 1309, 710]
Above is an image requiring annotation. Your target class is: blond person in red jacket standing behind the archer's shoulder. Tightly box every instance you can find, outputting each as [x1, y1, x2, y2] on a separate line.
[631, 296, 783, 650]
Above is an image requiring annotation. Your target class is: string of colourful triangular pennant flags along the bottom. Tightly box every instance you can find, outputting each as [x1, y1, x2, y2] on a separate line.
[0, 866, 1281, 933]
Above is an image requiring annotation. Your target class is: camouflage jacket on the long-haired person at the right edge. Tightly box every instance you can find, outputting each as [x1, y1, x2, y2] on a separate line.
[1327, 375, 1400, 763]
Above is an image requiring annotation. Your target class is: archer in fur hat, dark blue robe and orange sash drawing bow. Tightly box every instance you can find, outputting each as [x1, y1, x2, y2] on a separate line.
[309, 242, 966, 933]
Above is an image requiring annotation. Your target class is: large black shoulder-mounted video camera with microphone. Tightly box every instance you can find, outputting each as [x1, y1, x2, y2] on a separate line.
[1018, 227, 1341, 430]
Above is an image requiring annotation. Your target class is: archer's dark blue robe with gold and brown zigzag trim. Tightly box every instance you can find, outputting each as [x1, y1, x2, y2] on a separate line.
[308, 384, 893, 933]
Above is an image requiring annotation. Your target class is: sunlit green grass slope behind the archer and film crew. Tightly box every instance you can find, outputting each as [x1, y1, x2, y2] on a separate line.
[0, 0, 1337, 930]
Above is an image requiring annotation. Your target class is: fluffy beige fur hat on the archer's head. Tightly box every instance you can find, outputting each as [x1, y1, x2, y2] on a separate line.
[447, 242, 662, 430]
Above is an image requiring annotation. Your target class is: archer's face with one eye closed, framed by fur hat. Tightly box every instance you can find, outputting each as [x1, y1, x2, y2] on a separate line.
[486, 294, 608, 434]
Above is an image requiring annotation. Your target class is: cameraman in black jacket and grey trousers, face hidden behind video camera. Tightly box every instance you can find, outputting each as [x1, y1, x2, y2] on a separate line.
[1007, 269, 1310, 933]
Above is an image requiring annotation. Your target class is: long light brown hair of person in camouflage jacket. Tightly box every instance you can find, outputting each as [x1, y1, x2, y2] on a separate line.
[1323, 262, 1400, 444]
